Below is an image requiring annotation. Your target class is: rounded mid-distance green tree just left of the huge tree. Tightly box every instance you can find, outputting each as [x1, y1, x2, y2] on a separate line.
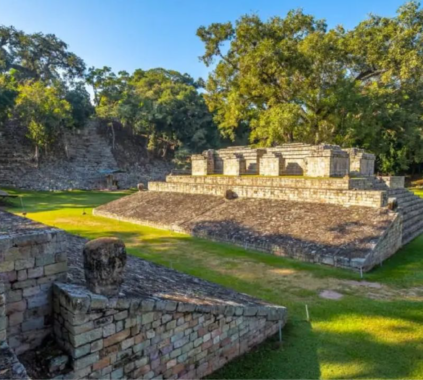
[131, 69, 218, 155]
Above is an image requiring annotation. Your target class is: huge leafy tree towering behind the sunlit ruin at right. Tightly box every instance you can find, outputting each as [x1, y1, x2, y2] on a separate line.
[197, 2, 423, 173]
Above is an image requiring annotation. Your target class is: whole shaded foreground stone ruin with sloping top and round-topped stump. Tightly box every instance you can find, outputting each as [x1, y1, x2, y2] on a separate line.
[0, 211, 287, 380]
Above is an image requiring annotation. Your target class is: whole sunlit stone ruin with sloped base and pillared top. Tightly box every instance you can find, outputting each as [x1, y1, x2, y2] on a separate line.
[94, 144, 423, 272]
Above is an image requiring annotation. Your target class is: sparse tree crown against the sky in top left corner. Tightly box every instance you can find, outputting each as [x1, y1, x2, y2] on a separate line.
[0, 26, 85, 83]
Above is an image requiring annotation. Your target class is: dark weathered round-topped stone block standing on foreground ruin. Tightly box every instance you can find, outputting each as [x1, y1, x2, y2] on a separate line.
[84, 238, 126, 297]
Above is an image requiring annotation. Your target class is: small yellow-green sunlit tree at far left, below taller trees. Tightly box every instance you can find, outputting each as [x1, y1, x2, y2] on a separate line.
[15, 81, 72, 161]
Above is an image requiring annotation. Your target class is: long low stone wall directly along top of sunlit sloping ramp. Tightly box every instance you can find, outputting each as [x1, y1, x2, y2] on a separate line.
[148, 182, 387, 208]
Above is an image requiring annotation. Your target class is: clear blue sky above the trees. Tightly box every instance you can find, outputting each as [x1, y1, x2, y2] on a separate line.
[0, 0, 410, 78]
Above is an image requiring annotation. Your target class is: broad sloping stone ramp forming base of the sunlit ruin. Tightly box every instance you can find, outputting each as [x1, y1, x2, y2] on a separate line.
[94, 191, 402, 271]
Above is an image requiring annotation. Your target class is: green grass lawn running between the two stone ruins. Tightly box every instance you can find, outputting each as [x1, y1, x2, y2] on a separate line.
[3, 190, 423, 380]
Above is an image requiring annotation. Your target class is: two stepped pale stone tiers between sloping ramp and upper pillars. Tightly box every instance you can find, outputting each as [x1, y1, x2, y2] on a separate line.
[148, 176, 388, 208]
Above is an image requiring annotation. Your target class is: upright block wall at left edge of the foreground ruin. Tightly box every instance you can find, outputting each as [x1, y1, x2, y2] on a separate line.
[0, 212, 67, 354]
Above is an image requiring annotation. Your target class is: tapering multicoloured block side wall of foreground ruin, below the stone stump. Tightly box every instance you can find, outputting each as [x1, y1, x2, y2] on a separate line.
[54, 283, 286, 380]
